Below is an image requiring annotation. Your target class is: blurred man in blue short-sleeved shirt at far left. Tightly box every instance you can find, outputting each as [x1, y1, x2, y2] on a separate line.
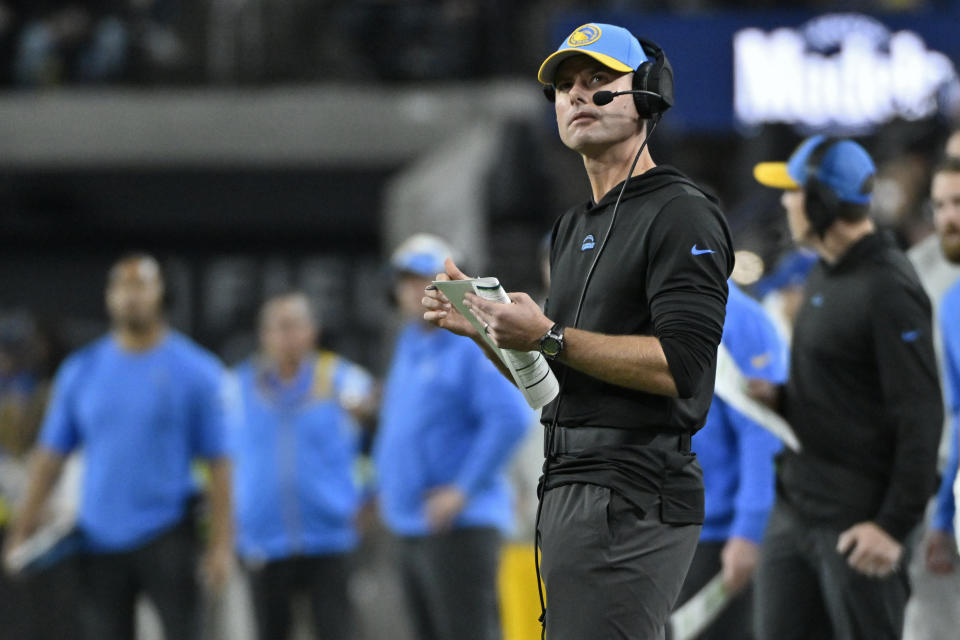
[6, 254, 233, 640]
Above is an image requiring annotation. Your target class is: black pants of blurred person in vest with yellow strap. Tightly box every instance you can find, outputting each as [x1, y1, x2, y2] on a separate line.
[248, 554, 353, 640]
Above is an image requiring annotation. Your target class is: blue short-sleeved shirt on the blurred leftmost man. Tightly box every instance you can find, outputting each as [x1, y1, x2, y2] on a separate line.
[39, 331, 226, 551]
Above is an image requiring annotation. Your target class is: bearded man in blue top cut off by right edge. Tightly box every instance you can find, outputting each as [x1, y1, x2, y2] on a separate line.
[924, 156, 960, 574]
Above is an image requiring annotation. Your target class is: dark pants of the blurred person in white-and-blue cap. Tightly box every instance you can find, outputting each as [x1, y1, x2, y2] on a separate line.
[399, 527, 501, 640]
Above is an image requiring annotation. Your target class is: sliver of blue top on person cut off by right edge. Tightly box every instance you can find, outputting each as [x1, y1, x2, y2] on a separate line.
[930, 282, 960, 533]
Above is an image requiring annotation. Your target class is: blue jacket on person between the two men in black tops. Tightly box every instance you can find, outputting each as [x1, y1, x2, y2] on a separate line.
[693, 282, 787, 543]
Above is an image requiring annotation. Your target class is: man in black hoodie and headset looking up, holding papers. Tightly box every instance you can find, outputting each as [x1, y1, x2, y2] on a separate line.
[424, 23, 733, 640]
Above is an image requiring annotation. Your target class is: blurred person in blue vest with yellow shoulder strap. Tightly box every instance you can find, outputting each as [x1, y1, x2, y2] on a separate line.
[230, 292, 374, 640]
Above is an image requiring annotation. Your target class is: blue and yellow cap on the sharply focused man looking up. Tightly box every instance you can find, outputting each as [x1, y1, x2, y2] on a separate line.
[537, 22, 649, 84]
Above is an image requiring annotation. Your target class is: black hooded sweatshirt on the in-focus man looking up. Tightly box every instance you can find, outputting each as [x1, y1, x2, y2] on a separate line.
[542, 166, 733, 523]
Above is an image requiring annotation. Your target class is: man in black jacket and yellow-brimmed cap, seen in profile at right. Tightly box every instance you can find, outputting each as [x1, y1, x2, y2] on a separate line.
[753, 136, 943, 640]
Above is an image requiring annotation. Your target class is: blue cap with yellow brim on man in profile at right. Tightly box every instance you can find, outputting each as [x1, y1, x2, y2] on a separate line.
[753, 135, 877, 204]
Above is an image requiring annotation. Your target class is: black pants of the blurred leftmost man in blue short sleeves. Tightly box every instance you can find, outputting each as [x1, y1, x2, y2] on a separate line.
[80, 518, 200, 640]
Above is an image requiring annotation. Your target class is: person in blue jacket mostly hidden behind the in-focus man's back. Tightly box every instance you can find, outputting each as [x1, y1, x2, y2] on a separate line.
[678, 282, 787, 640]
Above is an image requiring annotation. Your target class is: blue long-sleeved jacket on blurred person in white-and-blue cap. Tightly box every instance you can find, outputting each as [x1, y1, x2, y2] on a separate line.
[374, 323, 532, 536]
